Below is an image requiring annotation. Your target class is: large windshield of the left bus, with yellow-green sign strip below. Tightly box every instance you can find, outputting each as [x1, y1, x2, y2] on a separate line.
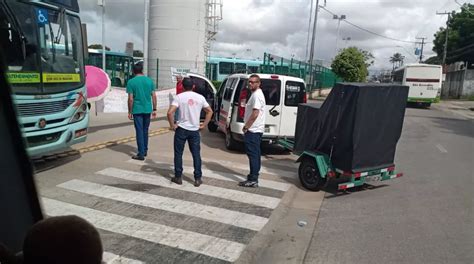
[0, 1, 84, 94]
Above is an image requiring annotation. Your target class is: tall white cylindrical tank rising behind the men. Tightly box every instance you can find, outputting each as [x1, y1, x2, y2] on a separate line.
[147, 0, 207, 89]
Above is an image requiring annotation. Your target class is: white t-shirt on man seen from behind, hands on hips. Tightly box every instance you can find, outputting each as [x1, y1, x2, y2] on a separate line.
[171, 91, 209, 131]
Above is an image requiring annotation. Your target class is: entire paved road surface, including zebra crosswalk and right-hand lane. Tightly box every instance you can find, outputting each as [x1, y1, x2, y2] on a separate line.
[31, 103, 474, 264]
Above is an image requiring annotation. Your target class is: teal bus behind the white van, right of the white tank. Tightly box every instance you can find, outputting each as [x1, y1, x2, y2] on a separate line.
[206, 57, 263, 82]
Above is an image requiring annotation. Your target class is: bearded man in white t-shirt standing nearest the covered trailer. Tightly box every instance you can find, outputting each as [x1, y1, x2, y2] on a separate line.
[239, 74, 266, 187]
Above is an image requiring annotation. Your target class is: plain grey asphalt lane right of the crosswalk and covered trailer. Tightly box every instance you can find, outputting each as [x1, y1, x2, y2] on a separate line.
[305, 108, 474, 263]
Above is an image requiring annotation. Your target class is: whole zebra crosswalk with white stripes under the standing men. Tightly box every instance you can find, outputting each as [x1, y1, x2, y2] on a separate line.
[42, 162, 291, 264]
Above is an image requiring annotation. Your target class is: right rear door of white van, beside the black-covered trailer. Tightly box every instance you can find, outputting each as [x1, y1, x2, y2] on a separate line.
[280, 81, 306, 137]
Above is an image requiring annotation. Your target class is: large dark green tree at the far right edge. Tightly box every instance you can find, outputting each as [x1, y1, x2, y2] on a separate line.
[433, 3, 474, 64]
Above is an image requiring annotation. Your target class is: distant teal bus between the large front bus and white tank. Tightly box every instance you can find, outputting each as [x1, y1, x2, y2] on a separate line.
[86, 49, 134, 87]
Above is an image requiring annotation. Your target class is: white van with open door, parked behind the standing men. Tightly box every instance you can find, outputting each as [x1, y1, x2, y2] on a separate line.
[209, 74, 306, 149]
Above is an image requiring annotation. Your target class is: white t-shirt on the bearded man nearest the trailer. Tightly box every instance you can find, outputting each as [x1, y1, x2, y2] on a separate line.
[244, 89, 266, 133]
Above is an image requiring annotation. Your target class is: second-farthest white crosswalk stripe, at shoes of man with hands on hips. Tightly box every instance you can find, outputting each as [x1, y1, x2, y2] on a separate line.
[97, 168, 280, 209]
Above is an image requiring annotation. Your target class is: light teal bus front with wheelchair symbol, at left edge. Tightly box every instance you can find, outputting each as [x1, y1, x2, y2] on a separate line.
[0, 0, 89, 157]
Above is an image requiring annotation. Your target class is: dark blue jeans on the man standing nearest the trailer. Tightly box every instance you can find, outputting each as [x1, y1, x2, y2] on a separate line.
[244, 131, 263, 182]
